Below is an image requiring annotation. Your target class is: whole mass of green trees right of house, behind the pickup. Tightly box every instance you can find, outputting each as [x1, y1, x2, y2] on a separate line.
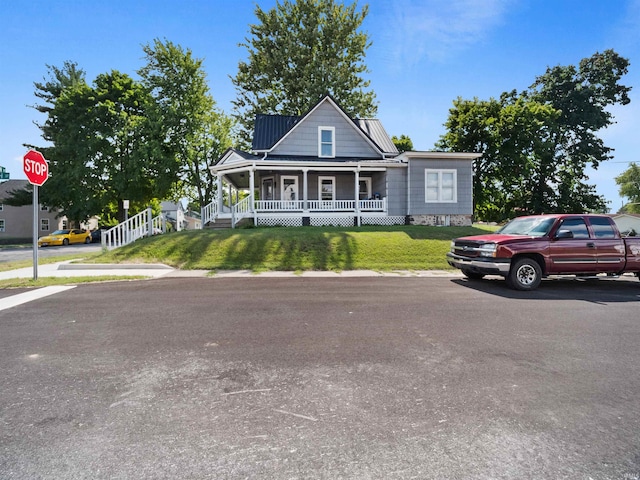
[436, 50, 630, 220]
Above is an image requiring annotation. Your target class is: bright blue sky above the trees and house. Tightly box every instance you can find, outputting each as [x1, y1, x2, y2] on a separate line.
[0, 0, 640, 211]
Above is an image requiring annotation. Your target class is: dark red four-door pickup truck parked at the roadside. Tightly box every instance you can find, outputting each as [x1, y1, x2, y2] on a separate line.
[447, 214, 640, 290]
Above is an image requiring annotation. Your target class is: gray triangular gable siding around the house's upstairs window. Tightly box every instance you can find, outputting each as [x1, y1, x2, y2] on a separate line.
[273, 103, 380, 158]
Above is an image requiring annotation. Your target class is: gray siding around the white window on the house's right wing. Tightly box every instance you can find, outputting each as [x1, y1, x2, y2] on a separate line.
[408, 159, 473, 215]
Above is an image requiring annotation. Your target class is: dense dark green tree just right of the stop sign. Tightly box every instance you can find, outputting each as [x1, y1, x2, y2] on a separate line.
[37, 71, 178, 221]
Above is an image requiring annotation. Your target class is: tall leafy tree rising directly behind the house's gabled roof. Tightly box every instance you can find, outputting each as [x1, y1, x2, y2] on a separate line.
[232, 0, 377, 147]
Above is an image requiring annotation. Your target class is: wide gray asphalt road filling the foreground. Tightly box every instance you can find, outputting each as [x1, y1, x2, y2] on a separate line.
[0, 277, 640, 480]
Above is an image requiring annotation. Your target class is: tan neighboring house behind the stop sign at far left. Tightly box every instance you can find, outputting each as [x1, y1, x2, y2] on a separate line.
[0, 180, 67, 243]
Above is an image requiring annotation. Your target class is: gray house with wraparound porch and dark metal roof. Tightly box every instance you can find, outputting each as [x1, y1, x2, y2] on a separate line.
[202, 96, 480, 226]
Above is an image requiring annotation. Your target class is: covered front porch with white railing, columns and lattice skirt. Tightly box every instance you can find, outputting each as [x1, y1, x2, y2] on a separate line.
[202, 162, 404, 227]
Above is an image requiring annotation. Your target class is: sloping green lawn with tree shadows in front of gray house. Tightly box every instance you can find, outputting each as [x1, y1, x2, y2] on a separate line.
[90, 225, 495, 272]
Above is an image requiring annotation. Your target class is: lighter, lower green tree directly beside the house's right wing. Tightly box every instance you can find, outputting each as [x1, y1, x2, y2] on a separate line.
[436, 92, 558, 221]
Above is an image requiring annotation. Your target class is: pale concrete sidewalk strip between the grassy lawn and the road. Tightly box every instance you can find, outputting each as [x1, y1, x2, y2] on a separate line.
[0, 260, 462, 280]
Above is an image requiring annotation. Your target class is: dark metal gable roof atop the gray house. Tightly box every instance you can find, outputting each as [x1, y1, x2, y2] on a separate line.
[251, 95, 399, 155]
